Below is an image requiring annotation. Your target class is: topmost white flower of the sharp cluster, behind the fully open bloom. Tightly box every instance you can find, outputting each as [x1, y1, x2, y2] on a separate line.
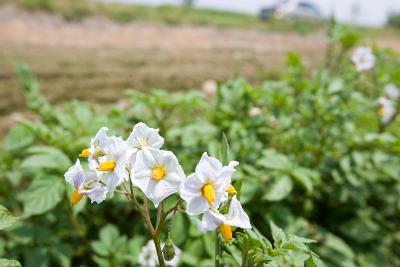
[126, 122, 164, 167]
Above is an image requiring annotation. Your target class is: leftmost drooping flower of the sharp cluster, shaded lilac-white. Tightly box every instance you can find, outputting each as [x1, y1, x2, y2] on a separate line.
[64, 159, 107, 205]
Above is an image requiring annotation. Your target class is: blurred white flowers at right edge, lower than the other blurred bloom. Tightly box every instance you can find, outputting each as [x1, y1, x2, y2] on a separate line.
[376, 84, 400, 123]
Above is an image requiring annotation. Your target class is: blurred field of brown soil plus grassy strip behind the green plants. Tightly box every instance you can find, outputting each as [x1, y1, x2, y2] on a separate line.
[0, 0, 400, 135]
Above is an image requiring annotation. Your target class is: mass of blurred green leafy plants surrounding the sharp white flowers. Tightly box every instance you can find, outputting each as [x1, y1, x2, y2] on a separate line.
[0, 22, 400, 267]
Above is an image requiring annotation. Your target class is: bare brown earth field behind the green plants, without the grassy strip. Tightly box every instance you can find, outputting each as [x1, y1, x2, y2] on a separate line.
[0, 6, 400, 136]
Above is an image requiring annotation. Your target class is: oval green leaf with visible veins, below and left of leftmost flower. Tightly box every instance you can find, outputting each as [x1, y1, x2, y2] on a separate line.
[20, 176, 65, 216]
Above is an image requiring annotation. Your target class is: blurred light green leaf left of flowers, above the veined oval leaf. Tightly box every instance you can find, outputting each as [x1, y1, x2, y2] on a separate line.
[21, 147, 71, 172]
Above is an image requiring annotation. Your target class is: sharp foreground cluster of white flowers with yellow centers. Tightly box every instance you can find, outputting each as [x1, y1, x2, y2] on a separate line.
[65, 123, 251, 266]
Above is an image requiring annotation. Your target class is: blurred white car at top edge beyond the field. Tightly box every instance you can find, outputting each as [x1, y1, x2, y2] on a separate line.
[259, 0, 322, 20]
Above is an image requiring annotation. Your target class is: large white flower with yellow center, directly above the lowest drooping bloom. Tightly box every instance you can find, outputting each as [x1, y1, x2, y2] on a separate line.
[180, 153, 239, 215]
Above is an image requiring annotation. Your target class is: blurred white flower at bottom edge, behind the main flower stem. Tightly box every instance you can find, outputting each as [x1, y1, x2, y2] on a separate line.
[138, 240, 182, 267]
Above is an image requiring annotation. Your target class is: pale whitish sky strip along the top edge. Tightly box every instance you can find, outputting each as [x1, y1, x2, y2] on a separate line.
[103, 0, 400, 26]
